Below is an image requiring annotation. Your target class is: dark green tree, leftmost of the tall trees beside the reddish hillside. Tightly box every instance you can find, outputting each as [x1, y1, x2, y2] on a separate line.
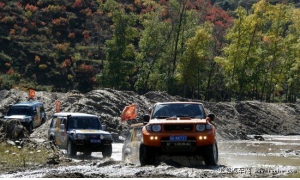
[104, 0, 138, 90]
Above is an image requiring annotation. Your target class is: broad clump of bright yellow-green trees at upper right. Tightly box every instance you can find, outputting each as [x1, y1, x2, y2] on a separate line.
[216, 0, 293, 102]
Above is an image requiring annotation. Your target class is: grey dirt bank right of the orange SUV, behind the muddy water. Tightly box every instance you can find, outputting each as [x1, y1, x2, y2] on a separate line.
[205, 101, 300, 140]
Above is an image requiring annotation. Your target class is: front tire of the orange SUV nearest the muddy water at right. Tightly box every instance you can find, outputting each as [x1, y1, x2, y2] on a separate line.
[204, 141, 219, 166]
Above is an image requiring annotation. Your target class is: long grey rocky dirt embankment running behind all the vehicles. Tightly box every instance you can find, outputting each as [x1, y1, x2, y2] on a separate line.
[0, 89, 300, 177]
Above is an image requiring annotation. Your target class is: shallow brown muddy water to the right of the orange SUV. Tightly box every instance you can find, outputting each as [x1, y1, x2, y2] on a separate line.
[218, 135, 300, 167]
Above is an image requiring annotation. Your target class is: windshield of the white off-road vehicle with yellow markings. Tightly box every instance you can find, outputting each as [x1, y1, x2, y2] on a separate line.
[68, 117, 102, 130]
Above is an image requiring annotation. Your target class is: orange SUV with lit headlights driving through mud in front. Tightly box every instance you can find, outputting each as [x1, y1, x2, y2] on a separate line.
[123, 102, 218, 166]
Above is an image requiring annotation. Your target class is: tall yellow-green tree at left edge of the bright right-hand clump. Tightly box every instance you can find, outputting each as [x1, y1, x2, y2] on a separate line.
[216, 7, 255, 100]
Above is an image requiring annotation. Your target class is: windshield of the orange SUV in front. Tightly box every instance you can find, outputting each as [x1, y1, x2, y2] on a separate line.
[152, 103, 205, 119]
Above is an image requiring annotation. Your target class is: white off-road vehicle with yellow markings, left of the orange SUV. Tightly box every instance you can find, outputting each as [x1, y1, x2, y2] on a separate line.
[48, 112, 113, 158]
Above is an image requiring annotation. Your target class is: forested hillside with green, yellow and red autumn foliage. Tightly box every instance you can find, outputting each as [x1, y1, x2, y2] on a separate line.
[0, 0, 300, 102]
